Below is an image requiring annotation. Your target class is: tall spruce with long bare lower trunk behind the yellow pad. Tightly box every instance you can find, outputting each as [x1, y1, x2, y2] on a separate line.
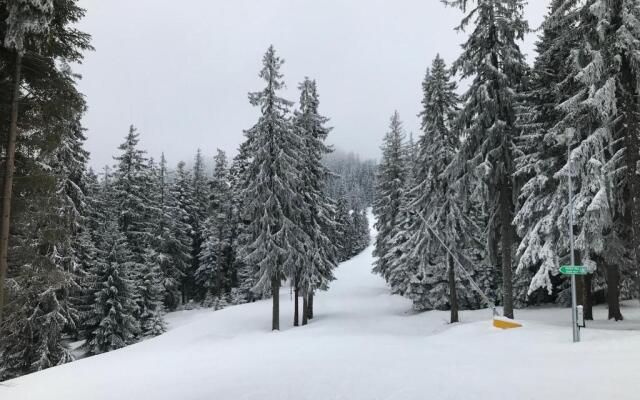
[444, 0, 529, 318]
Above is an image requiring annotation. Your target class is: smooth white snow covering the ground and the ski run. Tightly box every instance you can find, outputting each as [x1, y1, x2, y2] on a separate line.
[0, 223, 640, 400]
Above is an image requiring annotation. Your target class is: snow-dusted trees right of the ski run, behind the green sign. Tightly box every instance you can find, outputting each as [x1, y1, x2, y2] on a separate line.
[374, 0, 640, 321]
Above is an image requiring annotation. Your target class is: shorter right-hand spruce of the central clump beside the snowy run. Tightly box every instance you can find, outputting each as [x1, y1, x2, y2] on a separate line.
[291, 78, 336, 326]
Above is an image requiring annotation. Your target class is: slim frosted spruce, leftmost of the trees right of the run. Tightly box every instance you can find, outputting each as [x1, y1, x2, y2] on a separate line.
[373, 111, 406, 279]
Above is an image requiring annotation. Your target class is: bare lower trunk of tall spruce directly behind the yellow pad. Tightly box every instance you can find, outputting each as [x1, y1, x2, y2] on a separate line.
[498, 174, 513, 318]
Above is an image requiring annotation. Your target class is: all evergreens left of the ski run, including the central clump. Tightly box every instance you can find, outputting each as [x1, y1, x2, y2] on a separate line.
[0, 0, 368, 380]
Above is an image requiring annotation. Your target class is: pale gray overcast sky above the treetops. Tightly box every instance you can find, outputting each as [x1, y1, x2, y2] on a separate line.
[77, 0, 548, 167]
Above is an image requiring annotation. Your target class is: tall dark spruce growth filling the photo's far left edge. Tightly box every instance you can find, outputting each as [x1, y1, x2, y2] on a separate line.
[0, 1, 90, 380]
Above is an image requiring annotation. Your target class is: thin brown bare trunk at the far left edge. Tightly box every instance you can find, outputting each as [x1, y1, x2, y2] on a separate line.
[0, 52, 22, 325]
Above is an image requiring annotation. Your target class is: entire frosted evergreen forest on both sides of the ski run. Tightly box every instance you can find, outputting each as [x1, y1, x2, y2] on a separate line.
[0, 0, 640, 390]
